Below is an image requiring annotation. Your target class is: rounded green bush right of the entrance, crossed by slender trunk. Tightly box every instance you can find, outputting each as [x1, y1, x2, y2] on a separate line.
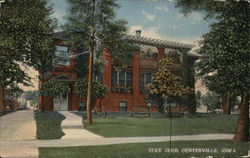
[75, 78, 108, 100]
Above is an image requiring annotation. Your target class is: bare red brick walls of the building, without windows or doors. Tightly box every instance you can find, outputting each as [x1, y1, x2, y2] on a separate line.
[39, 43, 165, 111]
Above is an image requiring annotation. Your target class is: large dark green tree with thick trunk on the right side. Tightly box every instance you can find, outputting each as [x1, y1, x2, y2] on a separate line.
[177, 0, 250, 141]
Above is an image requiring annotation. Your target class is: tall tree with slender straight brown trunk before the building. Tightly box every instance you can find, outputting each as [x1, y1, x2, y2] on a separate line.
[63, 0, 135, 124]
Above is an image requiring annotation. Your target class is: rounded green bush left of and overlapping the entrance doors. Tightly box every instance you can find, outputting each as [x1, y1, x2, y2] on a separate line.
[39, 79, 70, 97]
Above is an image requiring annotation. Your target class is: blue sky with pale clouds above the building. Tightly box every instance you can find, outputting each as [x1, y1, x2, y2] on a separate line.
[50, 0, 209, 43]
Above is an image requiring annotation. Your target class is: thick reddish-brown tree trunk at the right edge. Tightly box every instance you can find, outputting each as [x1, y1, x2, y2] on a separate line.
[233, 94, 249, 141]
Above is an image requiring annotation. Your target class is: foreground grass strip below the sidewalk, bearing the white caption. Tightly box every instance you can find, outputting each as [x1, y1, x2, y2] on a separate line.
[39, 140, 250, 158]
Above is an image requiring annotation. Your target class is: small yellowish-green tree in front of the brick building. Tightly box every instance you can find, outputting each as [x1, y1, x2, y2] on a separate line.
[146, 57, 191, 112]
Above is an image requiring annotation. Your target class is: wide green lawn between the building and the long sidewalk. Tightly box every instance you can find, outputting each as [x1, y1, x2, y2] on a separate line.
[85, 115, 237, 137]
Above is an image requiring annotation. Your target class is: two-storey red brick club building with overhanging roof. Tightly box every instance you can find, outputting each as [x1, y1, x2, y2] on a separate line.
[39, 31, 198, 111]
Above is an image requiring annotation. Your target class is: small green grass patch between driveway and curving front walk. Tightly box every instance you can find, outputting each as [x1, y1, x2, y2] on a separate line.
[35, 112, 65, 139]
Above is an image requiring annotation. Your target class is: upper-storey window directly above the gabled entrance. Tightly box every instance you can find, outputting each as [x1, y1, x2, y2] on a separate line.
[55, 46, 70, 65]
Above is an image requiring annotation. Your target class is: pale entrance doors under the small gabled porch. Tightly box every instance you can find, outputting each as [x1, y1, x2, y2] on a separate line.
[53, 93, 68, 111]
